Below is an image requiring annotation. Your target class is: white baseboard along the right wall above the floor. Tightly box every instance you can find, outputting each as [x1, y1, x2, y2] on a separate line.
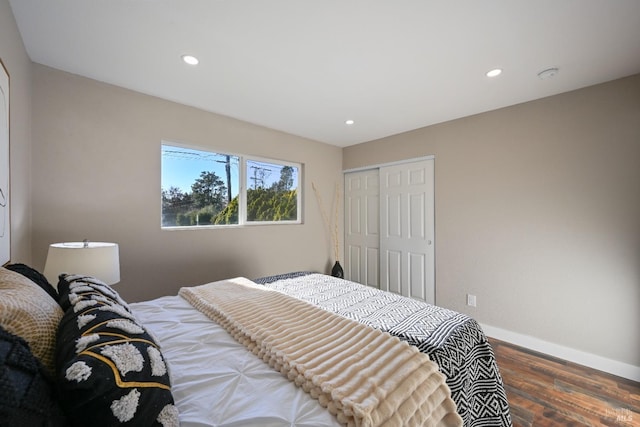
[481, 324, 640, 382]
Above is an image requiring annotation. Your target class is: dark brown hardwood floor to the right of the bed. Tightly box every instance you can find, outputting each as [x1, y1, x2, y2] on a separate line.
[489, 338, 640, 427]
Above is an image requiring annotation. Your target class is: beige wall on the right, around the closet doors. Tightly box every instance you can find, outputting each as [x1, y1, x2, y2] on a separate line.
[343, 75, 640, 367]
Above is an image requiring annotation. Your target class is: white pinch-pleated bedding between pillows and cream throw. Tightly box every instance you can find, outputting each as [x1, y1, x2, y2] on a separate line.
[129, 296, 340, 427]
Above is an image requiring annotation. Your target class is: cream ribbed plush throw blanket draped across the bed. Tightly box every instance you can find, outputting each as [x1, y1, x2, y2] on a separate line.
[179, 278, 462, 427]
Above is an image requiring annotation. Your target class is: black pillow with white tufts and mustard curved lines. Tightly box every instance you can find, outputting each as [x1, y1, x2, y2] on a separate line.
[56, 275, 179, 427]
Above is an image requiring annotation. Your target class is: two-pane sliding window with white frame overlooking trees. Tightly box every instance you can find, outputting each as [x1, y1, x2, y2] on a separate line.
[161, 143, 301, 228]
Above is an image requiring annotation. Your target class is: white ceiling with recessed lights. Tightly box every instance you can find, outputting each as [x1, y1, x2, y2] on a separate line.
[9, 0, 640, 146]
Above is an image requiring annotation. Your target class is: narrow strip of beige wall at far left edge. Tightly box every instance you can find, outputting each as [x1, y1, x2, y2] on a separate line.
[0, 0, 31, 264]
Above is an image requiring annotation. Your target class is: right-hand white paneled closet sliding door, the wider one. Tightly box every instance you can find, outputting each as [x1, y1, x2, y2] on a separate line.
[380, 159, 435, 304]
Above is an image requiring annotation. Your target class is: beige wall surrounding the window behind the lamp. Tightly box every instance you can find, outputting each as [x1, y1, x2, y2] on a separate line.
[33, 65, 342, 301]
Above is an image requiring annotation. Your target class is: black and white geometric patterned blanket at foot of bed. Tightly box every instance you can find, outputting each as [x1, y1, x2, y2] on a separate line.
[255, 273, 512, 427]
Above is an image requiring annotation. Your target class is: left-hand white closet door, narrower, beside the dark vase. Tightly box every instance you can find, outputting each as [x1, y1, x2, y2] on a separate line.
[344, 169, 380, 288]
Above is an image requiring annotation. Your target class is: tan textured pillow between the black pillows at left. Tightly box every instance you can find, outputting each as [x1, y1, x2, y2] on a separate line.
[0, 267, 64, 372]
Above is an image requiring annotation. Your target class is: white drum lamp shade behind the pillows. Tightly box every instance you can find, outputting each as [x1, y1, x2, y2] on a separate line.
[44, 242, 120, 286]
